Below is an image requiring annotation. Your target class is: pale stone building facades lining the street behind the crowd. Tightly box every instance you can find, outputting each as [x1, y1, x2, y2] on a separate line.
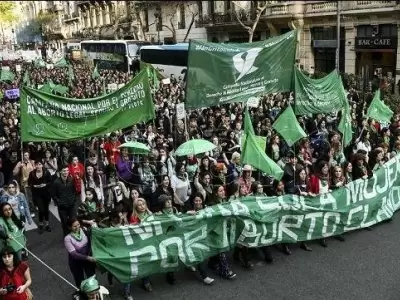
[12, 1, 400, 79]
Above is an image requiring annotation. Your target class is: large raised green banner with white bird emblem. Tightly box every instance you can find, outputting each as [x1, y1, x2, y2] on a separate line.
[185, 31, 297, 108]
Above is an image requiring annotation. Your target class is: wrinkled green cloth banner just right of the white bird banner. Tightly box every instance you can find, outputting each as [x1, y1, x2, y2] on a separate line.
[294, 68, 347, 115]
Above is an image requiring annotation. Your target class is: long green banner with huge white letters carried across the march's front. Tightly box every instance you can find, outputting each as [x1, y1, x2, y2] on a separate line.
[92, 156, 400, 282]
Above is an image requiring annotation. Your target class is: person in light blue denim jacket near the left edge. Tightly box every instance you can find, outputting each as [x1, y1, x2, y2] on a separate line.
[0, 180, 33, 224]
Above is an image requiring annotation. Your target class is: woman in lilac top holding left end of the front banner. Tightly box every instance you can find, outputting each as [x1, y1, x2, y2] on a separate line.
[64, 218, 96, 286]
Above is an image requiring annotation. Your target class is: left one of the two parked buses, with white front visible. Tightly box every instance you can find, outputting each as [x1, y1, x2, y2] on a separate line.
[81, 40, 151, 74]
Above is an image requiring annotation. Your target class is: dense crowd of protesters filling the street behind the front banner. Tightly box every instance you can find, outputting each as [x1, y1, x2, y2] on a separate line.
[0, 56, 400, 299]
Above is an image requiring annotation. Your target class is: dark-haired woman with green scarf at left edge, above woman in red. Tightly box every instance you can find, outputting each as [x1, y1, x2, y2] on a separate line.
[0, 202, 26, 260]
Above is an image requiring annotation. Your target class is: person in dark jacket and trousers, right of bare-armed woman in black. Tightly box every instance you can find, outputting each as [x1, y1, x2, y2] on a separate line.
[52, 165, 77, 236]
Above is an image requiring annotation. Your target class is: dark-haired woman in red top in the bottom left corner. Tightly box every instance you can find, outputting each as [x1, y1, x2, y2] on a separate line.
[0, 247, 33, 300]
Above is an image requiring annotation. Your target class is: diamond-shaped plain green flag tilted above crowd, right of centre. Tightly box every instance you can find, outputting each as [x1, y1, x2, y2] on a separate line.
[272, 105, 307, 147]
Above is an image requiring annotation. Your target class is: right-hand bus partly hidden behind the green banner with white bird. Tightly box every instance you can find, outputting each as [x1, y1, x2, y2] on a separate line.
[140, 43, 189, 79]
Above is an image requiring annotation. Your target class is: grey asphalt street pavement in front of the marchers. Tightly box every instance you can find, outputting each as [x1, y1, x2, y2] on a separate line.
[27, 207, 400, 300]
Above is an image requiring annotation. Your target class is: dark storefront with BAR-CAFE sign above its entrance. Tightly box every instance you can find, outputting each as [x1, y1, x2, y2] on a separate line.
[354, 24, 397, 78]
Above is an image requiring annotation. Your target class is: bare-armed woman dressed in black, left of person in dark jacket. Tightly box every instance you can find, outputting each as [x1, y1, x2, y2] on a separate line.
[28, 160, 53, 233]
